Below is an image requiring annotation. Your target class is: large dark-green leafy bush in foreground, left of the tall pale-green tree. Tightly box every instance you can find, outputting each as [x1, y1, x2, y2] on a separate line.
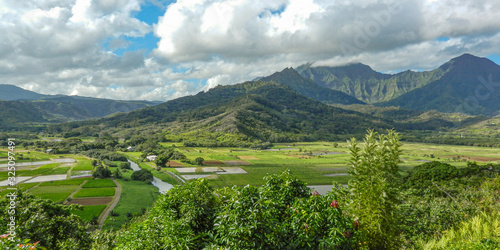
[111, 171, 358, 249]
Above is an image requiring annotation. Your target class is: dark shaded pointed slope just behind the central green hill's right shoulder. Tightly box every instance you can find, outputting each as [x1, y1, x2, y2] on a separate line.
[260, 68, 364, 105]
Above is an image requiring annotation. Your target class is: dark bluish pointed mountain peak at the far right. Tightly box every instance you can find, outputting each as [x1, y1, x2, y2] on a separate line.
[380, 54, 500, 116]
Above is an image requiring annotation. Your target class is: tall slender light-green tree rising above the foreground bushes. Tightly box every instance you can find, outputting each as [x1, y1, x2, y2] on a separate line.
[349, 130, 401, 249]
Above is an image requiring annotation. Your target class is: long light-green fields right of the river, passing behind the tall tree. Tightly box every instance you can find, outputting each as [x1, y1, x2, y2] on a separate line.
[162, 142, 500, 187]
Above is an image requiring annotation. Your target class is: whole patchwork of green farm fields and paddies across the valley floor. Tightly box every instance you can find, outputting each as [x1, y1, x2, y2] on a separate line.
[0, 142, 500, 229]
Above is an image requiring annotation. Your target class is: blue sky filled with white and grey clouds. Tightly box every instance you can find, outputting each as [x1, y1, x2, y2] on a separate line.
[0, 0, 500, 101]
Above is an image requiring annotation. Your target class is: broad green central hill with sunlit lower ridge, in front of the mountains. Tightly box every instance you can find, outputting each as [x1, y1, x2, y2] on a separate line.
[53, 81, 392, 142]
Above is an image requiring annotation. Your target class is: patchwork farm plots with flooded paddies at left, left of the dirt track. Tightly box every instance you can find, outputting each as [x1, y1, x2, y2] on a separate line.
[0, 151, 116, 221]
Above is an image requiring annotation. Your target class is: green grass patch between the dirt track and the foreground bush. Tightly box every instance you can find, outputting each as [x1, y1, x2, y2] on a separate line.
[103, 176, 158, 230]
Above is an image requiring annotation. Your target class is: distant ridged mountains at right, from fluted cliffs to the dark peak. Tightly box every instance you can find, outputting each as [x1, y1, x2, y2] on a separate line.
[296, 54, 500, 116]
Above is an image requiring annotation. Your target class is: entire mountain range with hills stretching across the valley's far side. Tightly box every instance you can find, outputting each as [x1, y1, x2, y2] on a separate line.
[0, 54, 500, 145]
